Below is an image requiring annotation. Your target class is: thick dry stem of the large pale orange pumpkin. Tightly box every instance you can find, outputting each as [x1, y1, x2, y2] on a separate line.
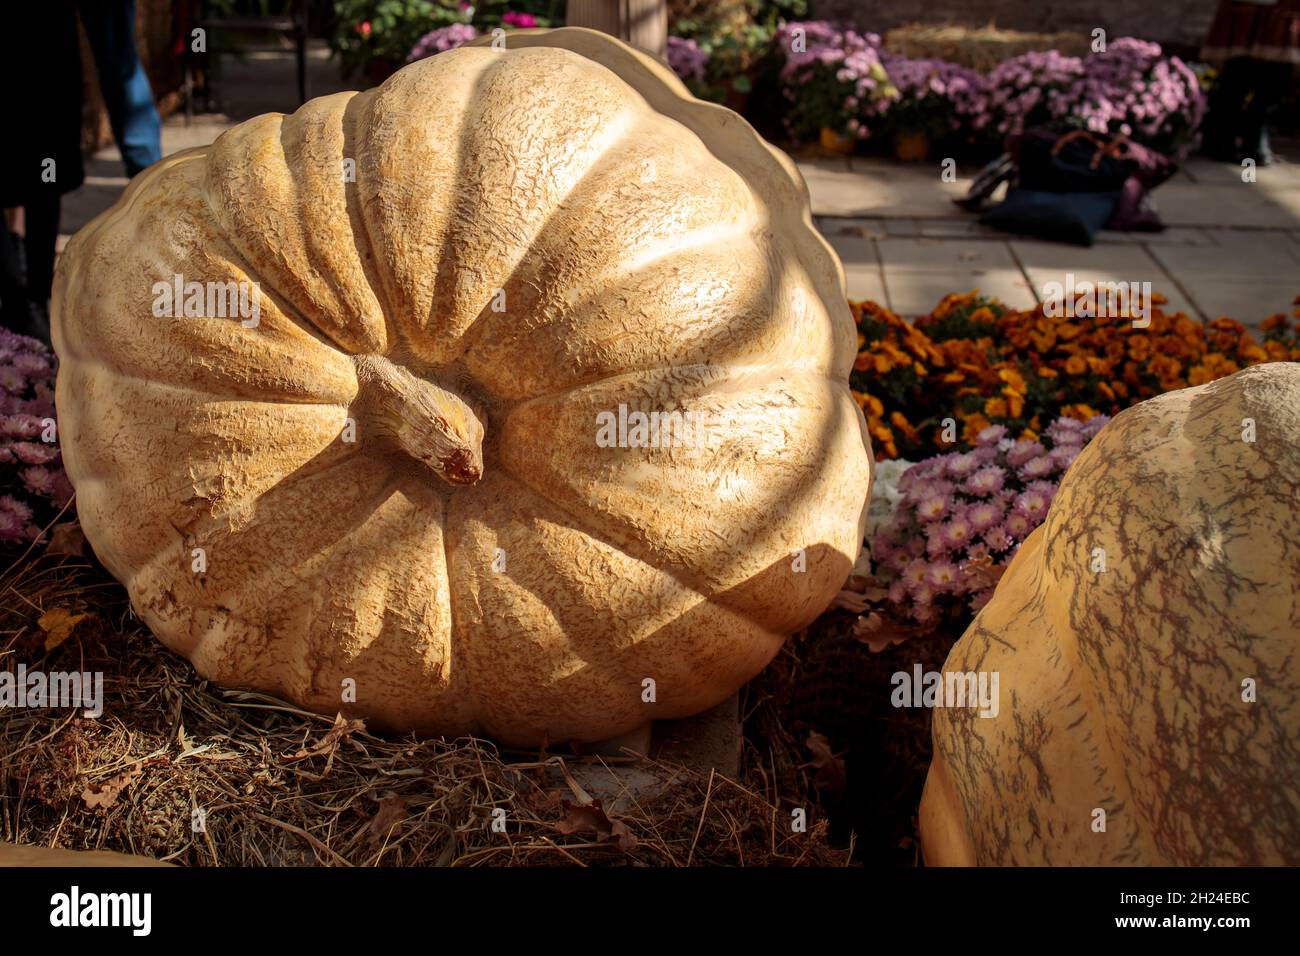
[352, 355, 484, 485]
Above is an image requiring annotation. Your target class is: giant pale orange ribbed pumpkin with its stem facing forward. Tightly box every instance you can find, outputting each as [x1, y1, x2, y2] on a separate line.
[55, 30, 870, 744]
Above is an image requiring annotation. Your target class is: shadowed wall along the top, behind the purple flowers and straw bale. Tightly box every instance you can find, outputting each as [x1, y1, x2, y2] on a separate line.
[814, 0, 1216, 52]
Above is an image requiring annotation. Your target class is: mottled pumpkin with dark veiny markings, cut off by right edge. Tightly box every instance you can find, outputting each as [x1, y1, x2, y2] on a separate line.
[920, 363, 1300, 865]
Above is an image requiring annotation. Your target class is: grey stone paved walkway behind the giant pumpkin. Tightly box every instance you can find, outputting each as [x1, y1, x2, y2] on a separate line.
[62, 46, 1300, 325]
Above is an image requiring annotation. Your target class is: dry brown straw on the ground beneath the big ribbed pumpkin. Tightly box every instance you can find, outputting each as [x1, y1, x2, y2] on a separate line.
[0, 546, 848, 866]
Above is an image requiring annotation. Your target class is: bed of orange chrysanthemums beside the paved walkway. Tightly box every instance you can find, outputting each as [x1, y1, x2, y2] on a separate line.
[849, 291, 1300, 460]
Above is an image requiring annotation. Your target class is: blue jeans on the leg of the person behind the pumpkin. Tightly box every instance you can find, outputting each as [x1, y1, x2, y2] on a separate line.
[77, 0, 163, 176]
